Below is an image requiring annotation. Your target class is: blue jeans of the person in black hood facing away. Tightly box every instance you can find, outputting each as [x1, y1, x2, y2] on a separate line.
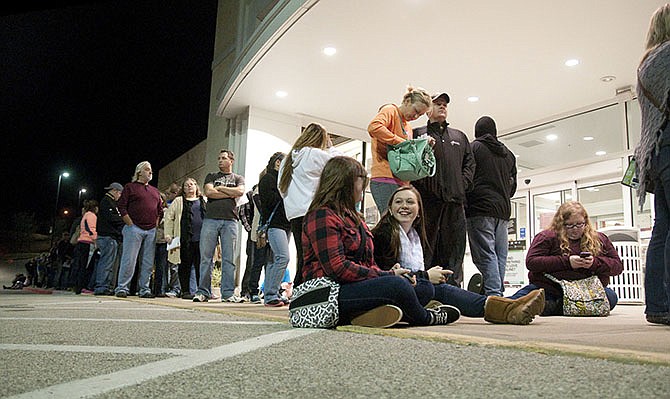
[466, 216, 508, 296]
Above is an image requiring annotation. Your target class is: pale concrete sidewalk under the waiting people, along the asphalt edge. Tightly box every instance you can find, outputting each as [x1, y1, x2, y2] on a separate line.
[0, 262, 670, 365]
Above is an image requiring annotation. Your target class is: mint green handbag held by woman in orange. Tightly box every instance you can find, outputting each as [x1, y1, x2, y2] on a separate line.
[387, 139, 435, 181]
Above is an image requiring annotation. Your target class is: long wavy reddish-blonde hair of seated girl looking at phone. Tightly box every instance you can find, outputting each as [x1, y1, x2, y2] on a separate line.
[549, 201, 602, 255]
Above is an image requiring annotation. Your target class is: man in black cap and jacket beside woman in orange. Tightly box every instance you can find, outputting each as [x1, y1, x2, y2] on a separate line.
[412, 93, 475, 287]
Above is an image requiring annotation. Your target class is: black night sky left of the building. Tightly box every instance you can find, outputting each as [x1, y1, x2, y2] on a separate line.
[0, 0, 217, 228]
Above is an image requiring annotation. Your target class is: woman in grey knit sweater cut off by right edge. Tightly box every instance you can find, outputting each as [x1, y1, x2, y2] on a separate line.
[635, 3, 670, 325]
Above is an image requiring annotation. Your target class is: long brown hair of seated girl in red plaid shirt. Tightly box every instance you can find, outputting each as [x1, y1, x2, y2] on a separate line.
[307, 156, 367, 224]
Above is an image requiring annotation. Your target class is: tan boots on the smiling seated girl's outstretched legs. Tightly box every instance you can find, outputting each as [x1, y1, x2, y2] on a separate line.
[484, 288, 544, 324]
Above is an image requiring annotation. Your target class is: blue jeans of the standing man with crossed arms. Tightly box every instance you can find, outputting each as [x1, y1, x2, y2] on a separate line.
[196, 218, 237, 299]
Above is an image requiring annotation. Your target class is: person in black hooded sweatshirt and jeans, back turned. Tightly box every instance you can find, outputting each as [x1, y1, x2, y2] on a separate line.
[465, 116, 516, 296]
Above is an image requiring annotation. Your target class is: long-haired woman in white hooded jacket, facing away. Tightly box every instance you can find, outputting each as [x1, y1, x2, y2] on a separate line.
[277, 123, 342, 287]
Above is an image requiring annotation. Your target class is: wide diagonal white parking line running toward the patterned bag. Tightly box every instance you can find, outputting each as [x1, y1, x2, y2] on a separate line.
[9, 329, 323, 399]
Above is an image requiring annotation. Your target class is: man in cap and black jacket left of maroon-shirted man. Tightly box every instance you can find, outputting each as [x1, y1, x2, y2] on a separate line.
[93, 182, 124, 295]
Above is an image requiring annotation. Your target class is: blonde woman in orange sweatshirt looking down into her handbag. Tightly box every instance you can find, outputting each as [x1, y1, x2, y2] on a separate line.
[368, 86, 432, 215]
